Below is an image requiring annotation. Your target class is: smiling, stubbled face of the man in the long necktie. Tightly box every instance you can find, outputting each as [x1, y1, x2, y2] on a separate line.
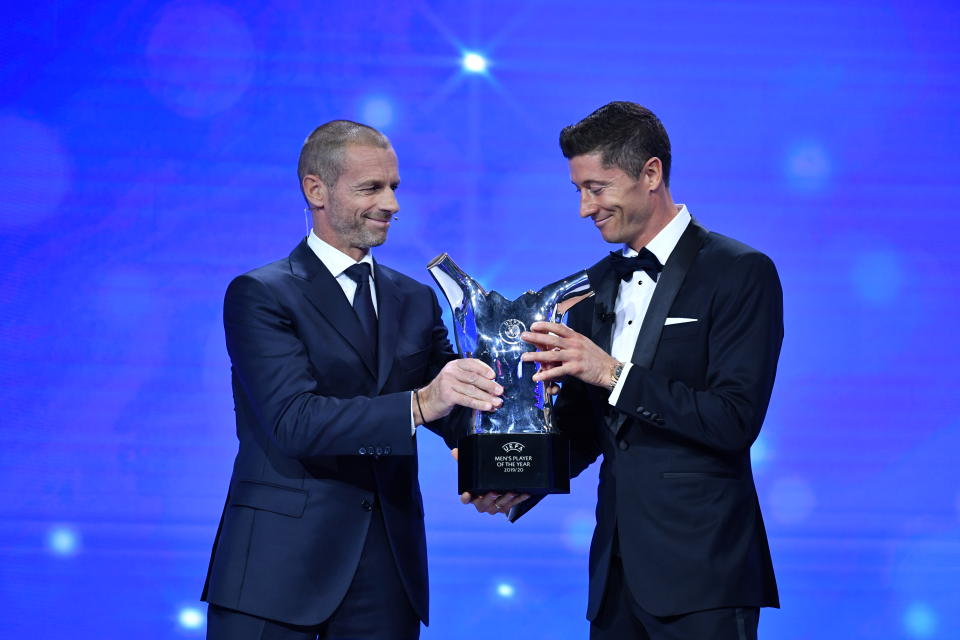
[303, 144, 400, 260]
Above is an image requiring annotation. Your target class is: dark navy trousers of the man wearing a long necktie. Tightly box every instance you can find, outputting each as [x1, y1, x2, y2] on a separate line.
[207, 505, 420, 640]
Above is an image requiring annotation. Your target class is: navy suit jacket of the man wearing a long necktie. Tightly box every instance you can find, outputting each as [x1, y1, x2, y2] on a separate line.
[202, 241, 456, 625]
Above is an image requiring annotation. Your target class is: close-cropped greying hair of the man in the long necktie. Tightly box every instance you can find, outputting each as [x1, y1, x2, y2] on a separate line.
[297, 120, 390, 190]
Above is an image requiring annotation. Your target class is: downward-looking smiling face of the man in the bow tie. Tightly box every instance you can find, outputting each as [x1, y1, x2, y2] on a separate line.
[569, 152, 663, 251]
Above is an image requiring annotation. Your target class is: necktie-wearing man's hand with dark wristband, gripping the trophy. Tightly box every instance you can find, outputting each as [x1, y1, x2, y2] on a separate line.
[413, 358, 503, 424]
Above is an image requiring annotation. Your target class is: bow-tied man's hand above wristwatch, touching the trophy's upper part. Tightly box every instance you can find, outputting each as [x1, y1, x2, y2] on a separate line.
[520, 322, 617, 389]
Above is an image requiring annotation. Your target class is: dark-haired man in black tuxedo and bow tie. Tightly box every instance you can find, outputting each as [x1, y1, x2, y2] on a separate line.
[516, 102, 783, 640]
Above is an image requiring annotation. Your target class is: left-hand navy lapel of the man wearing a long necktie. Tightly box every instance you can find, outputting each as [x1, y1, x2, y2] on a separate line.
[290, 241, 377, 376]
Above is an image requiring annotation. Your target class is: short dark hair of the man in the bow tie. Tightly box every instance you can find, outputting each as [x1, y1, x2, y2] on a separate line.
[560, 102, 670, 187]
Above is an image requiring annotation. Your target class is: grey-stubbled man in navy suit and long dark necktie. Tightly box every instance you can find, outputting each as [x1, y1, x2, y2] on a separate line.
[202, 120, 516, 640]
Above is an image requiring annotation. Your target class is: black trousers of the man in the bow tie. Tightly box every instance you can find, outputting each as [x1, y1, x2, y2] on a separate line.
[590, 554, 760, 640]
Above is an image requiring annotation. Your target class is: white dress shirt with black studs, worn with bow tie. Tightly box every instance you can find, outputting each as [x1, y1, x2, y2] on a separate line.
[610, 204, 690, 405]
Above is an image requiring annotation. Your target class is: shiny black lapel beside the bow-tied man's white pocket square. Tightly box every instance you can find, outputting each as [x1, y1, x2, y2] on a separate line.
[631, 220, 707, 367]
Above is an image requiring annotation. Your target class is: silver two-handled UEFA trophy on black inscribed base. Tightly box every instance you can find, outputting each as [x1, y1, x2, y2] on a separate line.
[427, 253, 590, 495]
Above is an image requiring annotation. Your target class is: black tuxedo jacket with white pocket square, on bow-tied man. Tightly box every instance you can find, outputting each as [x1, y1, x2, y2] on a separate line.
[516, 222, 783, 620]
